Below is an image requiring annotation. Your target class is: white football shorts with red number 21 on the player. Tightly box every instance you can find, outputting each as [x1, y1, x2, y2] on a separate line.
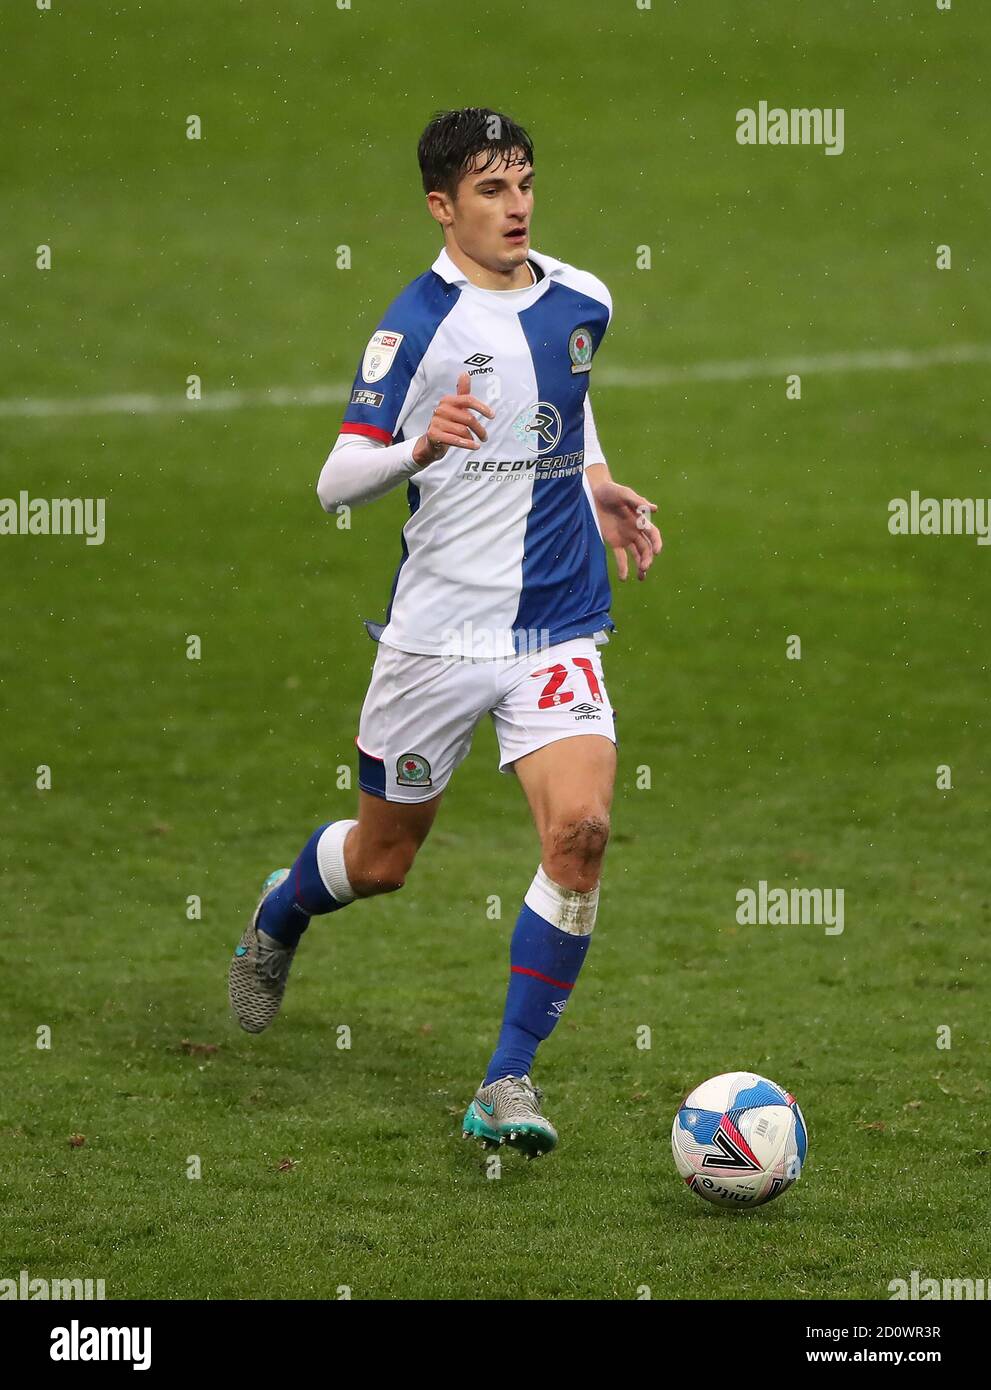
[354, 637, 616, 802]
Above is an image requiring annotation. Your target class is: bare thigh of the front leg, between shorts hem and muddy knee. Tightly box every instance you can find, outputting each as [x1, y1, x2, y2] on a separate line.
[513, 734, 616, 842]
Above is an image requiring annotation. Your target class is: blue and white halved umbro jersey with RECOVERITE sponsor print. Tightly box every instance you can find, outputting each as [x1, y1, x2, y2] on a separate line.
[341, 250, 613, 657]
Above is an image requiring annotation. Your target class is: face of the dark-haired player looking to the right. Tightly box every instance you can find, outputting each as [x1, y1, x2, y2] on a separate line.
[449, 156, 534, 274]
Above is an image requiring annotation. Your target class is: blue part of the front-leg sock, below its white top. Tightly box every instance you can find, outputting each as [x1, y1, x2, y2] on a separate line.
[482, 902, 591, 1086]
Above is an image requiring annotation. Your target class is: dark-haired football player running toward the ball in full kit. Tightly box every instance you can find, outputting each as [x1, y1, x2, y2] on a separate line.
[223, 107, 660, 1156]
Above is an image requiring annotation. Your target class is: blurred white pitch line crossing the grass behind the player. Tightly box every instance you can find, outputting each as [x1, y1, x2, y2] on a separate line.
[0, 343, 991, 420]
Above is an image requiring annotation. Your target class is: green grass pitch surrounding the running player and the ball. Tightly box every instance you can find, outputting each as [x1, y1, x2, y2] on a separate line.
[0, 0, 991, 1300]
